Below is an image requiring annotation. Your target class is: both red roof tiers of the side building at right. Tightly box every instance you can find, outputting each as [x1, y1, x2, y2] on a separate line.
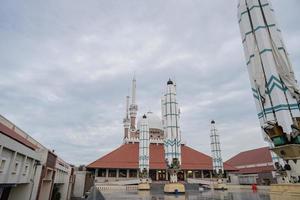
[227, 147, 274, 174]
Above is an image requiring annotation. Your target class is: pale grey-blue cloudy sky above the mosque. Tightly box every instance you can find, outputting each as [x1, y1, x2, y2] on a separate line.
[0, 0, 300, 164]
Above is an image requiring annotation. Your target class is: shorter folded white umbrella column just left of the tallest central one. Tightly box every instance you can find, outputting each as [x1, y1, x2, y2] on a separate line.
[139, 115, 149, 178]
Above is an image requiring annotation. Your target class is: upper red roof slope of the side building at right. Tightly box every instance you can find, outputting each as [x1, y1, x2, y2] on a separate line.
[227, 147, 272, 167]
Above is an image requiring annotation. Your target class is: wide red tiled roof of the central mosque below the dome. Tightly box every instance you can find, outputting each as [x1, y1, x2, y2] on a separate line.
[87, 143, 237, 171]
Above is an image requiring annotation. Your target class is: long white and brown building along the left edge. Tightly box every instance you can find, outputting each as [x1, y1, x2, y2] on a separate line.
[0, 115, 74, 200]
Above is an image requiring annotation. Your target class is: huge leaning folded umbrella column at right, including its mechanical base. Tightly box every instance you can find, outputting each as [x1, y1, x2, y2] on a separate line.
[238, 0, 300, 182]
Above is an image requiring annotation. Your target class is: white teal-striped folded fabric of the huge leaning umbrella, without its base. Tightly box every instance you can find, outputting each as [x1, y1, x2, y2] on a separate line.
[238, 0, 300, 140]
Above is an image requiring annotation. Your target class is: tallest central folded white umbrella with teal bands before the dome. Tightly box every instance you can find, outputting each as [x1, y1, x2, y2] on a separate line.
[161, 80, 181, 166]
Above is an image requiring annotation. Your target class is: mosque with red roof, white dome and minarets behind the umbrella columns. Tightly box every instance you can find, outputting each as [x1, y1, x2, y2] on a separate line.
[87, 78, 237, 182]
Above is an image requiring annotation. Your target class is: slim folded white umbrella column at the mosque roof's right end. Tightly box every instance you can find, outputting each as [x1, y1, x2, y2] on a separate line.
[210, 120, 224, 175]
